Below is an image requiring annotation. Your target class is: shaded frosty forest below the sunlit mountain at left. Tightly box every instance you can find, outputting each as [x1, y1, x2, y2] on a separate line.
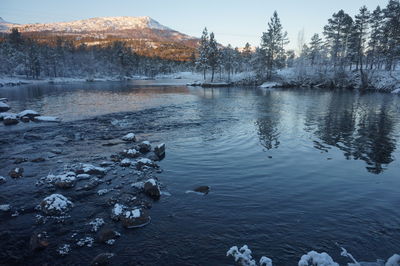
[0, 29, 189, 79]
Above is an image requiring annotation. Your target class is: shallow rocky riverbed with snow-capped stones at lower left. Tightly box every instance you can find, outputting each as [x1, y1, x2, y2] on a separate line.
[0, 107, 178, 265]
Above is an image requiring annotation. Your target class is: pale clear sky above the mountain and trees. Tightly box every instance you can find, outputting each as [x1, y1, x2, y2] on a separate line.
[0, 0, 388, 48]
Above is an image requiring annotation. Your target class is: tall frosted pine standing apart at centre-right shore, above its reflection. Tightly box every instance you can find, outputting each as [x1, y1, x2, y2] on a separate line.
[261, 11, 289, 79]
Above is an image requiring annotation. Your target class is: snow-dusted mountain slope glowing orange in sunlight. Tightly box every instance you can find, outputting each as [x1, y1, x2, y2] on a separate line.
[0, 17, 198, 61]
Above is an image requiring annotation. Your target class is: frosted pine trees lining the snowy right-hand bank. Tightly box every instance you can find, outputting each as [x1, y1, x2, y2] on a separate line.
[196, 0, 400, 83]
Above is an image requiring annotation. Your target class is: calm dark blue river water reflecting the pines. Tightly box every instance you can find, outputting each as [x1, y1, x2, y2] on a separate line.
[0, 82, 400, 265]
